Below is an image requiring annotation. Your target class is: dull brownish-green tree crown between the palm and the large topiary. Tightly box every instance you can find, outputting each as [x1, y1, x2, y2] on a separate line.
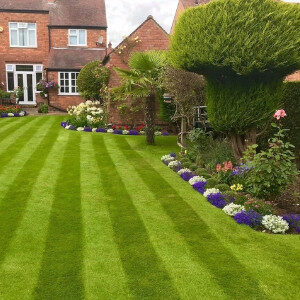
[164, 67, 205, 124]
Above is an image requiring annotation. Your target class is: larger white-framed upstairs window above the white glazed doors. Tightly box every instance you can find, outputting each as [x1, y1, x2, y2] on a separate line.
[9, 22, 37, 48]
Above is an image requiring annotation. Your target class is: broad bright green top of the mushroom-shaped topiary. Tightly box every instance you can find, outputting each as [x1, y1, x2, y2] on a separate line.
[170, 0, 300, 78]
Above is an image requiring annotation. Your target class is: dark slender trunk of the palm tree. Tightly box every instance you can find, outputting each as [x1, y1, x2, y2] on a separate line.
[145, 92, 156, 145]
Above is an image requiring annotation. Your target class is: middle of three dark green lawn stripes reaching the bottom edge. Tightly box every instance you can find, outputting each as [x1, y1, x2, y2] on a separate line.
[93, 135, 179, 299]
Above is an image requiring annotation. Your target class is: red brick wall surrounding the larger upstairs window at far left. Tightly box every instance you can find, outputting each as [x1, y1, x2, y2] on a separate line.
[0, 12, 49, 84]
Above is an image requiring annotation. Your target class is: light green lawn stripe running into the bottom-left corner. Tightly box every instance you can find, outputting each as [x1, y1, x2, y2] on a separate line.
[0, 126, 67, 299]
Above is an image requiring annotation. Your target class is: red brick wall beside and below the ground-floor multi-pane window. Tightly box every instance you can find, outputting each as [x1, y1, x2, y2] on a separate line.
[48, 71, 84, 110]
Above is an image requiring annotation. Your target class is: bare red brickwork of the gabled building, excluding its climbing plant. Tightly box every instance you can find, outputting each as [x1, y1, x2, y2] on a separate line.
[108, 18, 169, 124]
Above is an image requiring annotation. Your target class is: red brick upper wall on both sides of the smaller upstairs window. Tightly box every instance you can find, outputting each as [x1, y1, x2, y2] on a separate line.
[51, 28, 107, 48]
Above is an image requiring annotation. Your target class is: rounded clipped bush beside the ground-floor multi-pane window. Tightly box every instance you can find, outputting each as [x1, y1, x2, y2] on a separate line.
[77, 60, 110, 100]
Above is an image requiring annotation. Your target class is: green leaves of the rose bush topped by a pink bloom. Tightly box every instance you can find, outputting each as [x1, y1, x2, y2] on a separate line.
[244, 117, 298, 200]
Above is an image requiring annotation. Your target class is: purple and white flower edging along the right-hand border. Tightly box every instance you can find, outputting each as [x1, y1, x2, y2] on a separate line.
[161, 153, 300, 234]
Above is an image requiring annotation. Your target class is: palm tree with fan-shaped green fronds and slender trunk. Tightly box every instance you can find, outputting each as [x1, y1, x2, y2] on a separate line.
[113, 51, 166, 145]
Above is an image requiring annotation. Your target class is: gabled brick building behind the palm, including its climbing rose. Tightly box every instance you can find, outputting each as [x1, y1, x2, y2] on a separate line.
[104, 16, 170, 124]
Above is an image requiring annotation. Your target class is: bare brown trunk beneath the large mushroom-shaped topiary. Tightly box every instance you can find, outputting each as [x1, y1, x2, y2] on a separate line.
[229, 128, 257, 161]
